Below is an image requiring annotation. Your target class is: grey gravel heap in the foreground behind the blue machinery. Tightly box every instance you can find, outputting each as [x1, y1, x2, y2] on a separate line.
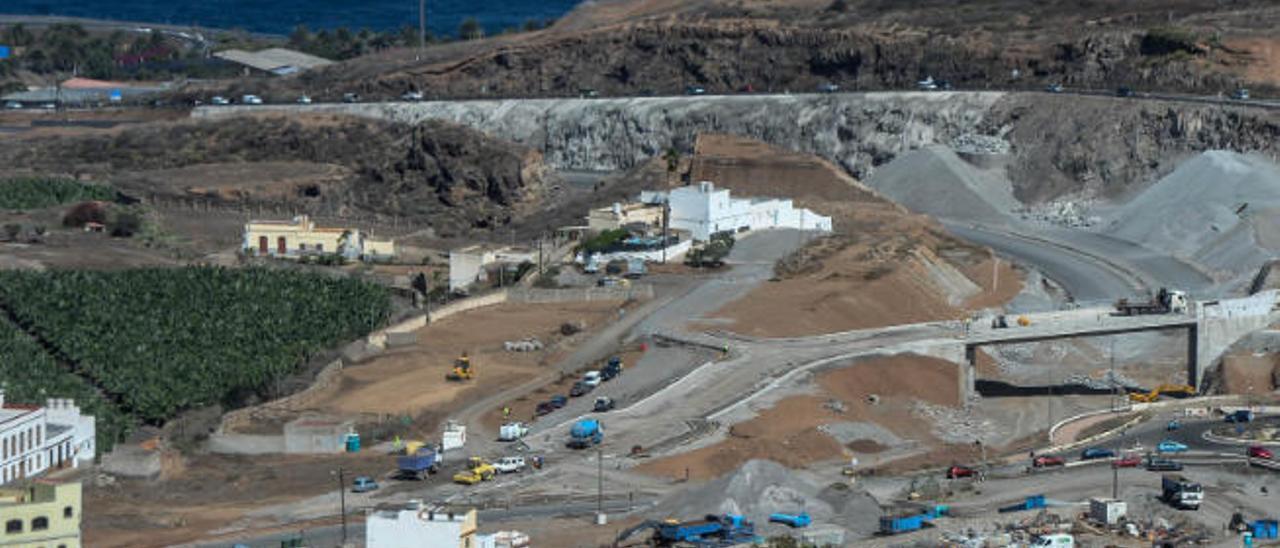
[655, 460, 881, 536]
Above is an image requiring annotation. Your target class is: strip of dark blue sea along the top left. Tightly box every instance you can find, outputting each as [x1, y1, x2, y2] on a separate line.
[0, 0, 581, 36]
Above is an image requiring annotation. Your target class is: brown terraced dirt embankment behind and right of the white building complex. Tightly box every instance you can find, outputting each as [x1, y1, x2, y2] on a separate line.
[690, 136, 1021, 337]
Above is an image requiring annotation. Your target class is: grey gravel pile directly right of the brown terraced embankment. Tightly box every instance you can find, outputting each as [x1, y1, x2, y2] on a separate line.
[867, 145, 1020, 225]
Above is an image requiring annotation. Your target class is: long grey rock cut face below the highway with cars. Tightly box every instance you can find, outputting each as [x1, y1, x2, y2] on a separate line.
[196, 92, 1280, 202]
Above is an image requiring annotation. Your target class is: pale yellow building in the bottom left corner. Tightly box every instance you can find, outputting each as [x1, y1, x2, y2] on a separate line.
[0, 480, 81, 548]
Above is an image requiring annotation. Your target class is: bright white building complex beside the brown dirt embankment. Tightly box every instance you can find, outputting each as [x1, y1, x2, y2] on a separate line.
[640, 181, 831, 241]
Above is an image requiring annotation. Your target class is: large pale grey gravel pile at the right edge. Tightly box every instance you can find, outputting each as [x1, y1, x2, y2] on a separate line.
[1107, 150, 1280, 280]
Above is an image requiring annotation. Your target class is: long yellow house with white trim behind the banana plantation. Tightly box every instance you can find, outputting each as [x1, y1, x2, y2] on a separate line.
[242, 215, 396, 260]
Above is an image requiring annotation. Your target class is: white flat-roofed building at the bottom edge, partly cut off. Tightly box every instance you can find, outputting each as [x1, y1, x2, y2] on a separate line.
[365, 501, 480, 548]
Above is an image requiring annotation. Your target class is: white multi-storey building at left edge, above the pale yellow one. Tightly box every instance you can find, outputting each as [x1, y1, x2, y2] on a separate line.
[0, 391, 96, 485]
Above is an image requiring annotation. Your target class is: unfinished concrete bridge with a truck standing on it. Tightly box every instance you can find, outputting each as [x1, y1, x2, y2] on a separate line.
[936, 291, 1280, 393]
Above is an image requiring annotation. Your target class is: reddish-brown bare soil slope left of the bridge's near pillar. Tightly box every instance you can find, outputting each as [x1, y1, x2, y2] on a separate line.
[636, 356, 960, 480]
